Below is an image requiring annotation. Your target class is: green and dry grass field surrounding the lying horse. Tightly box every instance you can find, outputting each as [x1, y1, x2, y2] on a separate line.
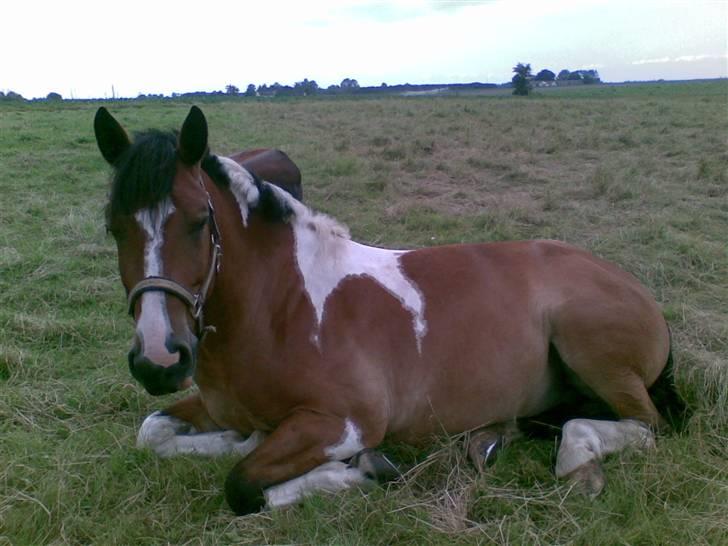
[0, 82, 728, 545]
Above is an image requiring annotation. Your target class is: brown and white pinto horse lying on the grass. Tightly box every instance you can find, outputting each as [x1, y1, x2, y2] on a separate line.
[94, 106, 674, 515]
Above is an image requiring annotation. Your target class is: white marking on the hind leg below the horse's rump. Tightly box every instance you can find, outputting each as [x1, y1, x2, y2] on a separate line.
[556, 419, 655, 478]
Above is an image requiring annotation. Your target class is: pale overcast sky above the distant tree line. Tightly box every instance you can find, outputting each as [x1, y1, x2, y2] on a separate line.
[0, 0, 728, 98]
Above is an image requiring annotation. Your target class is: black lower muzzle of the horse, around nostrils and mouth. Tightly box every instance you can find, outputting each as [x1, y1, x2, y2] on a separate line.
[129, 337, 197, 396]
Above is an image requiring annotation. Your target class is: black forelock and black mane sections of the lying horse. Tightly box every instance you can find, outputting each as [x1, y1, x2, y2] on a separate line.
[106, 129, 293, 222]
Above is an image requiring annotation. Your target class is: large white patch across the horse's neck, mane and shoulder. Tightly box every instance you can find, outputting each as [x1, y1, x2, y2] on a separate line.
[219, 157, 427, 352]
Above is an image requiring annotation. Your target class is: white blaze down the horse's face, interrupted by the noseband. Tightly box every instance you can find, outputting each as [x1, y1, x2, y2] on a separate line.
[134, 199, 179, 366]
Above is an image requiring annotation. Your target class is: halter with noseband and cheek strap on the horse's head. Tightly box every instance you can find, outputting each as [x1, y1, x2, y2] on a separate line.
[127, 194, 222, 340]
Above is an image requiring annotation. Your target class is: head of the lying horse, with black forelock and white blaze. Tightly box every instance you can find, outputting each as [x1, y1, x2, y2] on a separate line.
[94, 107, 219, 395]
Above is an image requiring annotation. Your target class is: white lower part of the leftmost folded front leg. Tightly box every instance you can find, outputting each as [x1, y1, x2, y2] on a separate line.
[137, 411, 265, 457]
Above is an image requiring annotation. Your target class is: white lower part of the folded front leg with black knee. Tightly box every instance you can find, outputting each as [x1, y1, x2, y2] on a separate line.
[264, 461, 376, 508]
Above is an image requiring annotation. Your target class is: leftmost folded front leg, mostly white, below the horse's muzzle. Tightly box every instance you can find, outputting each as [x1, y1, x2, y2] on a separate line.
[137, 393, 264, 457]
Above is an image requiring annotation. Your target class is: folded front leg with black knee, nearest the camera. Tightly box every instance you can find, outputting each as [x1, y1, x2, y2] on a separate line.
[225, 410, 392, 515]
